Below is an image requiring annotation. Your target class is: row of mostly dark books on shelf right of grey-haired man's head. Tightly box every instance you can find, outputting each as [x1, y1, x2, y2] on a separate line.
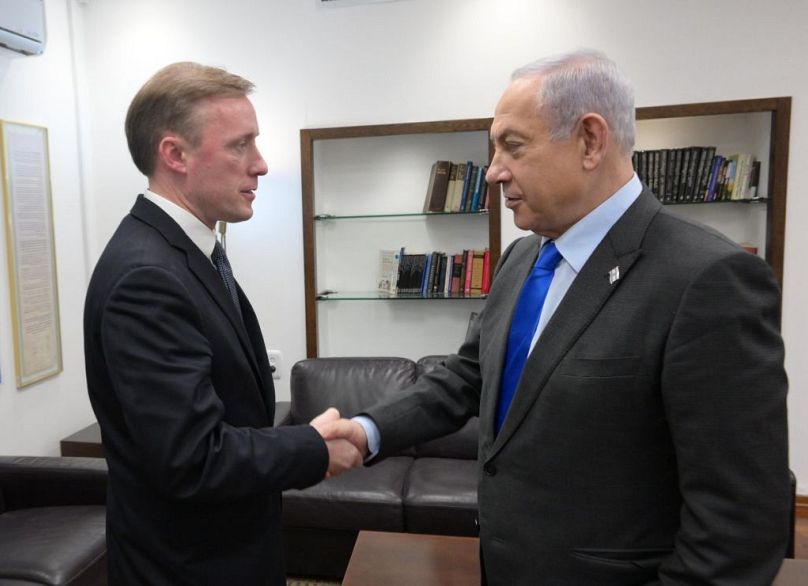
[632, 146, 760, 203]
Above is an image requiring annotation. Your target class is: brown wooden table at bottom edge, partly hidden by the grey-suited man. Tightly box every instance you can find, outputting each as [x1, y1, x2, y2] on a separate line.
[342, 531, 808, 586]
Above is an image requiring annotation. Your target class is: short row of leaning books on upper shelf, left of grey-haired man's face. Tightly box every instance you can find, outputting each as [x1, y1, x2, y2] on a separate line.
[424, 161, 488, 212]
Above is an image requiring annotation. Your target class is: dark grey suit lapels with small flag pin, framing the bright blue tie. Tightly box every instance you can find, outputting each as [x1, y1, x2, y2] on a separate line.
[485, 189, 661, 458]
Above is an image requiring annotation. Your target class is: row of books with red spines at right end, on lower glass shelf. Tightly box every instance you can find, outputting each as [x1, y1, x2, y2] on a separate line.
[378, 248, 491, 297]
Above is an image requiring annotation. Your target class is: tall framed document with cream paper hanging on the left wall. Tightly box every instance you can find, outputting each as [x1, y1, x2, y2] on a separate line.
[0, 120, 62, 388]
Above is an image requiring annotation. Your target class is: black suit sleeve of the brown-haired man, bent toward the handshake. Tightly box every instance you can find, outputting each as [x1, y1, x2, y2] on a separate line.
[100, 267, 328, 502]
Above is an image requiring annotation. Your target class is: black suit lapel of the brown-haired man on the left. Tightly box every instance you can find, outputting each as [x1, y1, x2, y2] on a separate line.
[131, 195, 266, 387]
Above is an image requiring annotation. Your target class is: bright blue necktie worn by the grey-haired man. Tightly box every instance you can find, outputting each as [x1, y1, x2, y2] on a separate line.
[495, 242, 561, 433]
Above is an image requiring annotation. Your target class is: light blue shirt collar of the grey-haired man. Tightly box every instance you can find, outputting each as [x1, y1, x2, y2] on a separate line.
[542, 173, 642, 274]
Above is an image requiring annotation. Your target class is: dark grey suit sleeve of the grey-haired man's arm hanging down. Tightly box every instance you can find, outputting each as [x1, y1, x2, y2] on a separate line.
[659, 252, 789, 586]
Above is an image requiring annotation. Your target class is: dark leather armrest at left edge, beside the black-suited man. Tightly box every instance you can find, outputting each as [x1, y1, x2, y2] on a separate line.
[0, 456, 107, 510]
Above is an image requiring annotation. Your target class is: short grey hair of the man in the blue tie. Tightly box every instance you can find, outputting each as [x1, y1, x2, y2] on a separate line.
[511, 49, 634, 156]
